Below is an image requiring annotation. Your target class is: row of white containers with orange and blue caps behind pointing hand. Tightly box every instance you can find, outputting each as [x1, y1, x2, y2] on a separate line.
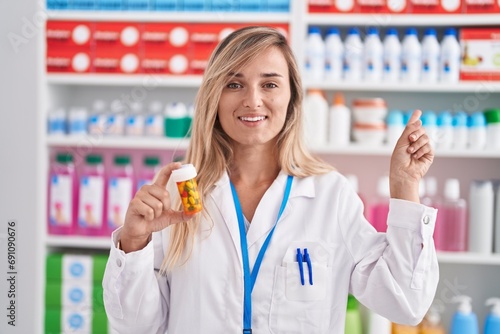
[304, 89, 500, 150]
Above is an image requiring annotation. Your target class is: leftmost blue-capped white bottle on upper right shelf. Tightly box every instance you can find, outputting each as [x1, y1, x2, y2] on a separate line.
[305, 27, 325, 83]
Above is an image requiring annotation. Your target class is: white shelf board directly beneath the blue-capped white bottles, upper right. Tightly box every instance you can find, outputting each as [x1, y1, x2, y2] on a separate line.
[304, 82, 500, 93]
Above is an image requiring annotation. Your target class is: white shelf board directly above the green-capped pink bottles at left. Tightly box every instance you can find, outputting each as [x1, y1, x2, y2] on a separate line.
[47, 134, 189, 150]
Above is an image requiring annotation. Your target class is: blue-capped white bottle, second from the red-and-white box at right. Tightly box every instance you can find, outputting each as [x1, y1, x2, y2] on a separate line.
[421, 28, 440, 83]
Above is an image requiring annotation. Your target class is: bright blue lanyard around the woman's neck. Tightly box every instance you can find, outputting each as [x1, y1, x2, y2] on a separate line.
[231, 175, 293, 334]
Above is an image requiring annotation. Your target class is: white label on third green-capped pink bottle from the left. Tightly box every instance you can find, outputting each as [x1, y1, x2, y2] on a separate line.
[108, 177, 132, 230]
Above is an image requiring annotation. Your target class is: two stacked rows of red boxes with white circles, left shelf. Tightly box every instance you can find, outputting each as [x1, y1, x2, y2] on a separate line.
[46, 20, 288, 75]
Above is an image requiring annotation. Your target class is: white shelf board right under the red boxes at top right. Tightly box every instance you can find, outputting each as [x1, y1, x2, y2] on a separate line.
[304, 13, 500, 27]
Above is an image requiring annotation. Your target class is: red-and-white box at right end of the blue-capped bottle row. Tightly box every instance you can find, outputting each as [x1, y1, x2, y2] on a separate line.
[460, 28, 500, 81]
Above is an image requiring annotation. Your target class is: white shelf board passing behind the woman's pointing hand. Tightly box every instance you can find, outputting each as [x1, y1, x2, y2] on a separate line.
[314, 144, 500, 159]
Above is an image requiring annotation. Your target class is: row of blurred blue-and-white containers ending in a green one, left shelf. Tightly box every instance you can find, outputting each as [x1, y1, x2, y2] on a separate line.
[47, 100, 194, 138]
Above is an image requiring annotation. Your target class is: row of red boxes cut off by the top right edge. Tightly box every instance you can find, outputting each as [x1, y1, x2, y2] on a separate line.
[309, 0, 500, 15]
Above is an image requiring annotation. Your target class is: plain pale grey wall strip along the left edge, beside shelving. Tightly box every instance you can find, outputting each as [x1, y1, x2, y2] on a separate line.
[0, 0, 44, 334]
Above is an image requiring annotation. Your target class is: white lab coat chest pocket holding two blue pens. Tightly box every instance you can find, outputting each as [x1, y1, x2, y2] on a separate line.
[269, 262, 333, 334]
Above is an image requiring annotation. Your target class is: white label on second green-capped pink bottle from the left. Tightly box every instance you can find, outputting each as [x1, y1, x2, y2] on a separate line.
[78, 176, 104, 228]
